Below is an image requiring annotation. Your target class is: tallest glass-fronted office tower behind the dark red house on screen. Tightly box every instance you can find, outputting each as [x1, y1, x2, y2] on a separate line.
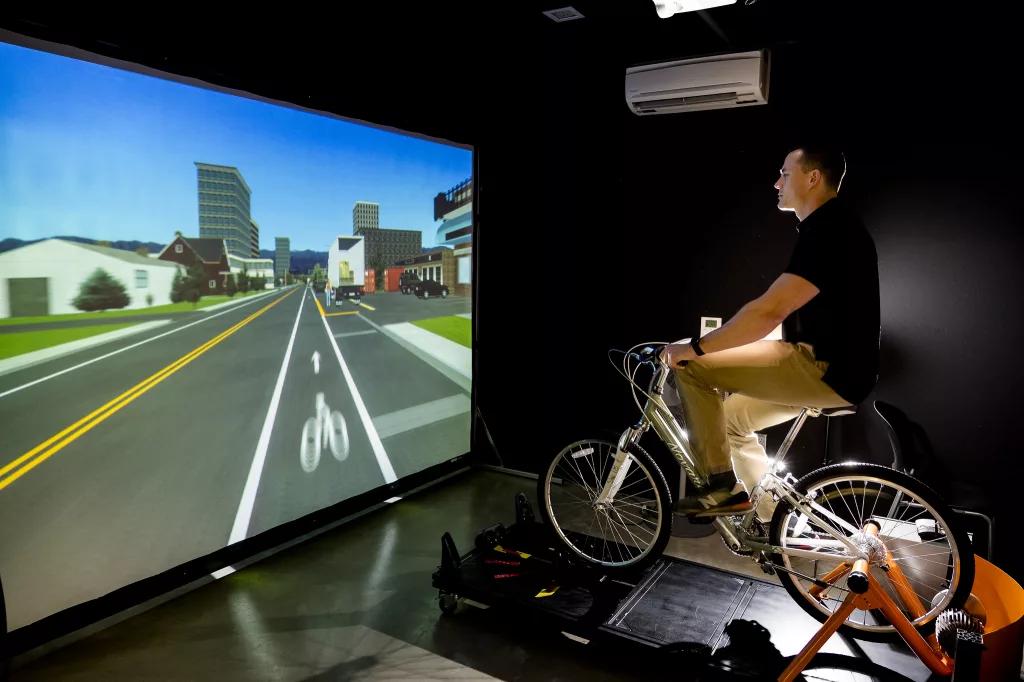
[196, 162, 251, 258]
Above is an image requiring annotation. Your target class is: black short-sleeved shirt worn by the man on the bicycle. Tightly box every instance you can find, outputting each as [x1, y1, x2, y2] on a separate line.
[782, 199, 881, 404]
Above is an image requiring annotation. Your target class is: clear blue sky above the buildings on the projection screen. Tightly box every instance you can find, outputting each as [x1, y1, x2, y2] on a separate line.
[0, 42, 472, 251]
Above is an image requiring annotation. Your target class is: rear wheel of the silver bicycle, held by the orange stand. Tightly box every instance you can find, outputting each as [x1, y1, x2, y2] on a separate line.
[771, 463, 974, 641]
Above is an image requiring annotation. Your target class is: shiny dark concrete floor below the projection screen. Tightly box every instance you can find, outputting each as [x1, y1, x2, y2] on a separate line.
[6, 471, 897, 682]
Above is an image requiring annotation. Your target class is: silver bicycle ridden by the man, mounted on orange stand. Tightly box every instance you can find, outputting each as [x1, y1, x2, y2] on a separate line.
[538, 343, 974, 641]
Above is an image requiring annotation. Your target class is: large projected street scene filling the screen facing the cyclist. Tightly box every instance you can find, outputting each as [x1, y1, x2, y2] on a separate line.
[0, 43, 473, 630]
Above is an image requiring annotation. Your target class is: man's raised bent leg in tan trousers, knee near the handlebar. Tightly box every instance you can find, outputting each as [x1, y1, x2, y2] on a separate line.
[676, 341, 849, 509]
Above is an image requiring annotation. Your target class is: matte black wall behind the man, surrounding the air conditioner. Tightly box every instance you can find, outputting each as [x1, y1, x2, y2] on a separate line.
[477, 7, 1024, 577]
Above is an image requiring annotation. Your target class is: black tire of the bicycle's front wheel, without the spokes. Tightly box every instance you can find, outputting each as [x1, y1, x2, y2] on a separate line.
[537, 438, 673, 574]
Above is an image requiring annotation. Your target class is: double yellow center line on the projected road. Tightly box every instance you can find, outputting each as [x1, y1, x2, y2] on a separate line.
[0, 290, 295, 491]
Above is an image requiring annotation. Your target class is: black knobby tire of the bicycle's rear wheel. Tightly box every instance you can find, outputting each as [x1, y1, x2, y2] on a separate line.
[769, 462, 975, 642]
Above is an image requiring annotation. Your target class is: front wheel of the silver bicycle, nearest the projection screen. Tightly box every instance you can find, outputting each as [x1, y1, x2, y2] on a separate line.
[537, 440, 672, 571]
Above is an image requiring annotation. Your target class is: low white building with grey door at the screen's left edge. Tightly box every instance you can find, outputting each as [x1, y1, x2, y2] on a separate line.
[0, 239, 184, 317]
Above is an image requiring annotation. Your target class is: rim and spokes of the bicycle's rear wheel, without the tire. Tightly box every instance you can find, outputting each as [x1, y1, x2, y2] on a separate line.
[772, 467, 969, 636]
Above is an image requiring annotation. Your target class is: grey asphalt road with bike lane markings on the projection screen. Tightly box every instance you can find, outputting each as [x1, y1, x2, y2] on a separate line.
[0, 288, 470, 629]
